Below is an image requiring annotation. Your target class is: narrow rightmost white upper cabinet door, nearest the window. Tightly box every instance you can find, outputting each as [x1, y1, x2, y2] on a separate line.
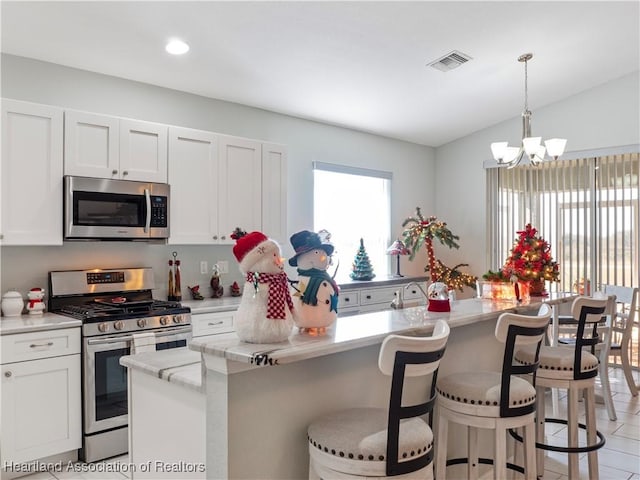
[262, 143, 289, 245]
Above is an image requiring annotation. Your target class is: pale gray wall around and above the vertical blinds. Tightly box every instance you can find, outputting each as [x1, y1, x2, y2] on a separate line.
[435, 72, 640, 282]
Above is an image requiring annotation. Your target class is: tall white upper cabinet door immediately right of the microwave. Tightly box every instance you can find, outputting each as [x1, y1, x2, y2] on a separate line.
[169, 127, 218, 245]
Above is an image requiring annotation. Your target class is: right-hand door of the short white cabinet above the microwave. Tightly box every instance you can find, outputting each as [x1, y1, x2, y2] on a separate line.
[120, 119, 167, 183]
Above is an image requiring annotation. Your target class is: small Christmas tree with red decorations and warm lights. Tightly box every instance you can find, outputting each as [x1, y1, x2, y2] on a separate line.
[502, 223, 560, 282]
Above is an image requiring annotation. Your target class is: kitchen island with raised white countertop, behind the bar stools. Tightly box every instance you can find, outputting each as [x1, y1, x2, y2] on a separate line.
[190, 295, 572, 479]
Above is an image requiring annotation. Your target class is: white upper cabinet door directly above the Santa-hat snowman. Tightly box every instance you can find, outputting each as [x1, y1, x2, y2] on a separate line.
[218, 135, 262, 243]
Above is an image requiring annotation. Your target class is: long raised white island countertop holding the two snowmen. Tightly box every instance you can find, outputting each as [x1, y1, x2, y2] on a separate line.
[189, 294, 571, 366]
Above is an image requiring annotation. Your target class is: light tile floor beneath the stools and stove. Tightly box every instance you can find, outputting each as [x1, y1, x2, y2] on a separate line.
[10, 368, 640, 480]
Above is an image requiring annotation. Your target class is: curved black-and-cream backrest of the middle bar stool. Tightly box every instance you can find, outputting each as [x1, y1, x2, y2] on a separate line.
[495, 303, 551, 418]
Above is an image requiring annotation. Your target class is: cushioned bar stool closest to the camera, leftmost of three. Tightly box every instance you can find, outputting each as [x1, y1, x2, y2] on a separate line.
[308, 320, 449, 480]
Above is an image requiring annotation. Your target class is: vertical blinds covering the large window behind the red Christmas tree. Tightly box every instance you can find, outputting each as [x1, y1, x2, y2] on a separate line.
[487, 153, 640, 291]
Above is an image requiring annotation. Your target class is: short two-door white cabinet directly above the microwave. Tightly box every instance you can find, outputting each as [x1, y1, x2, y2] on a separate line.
[64, 110, 167, 183]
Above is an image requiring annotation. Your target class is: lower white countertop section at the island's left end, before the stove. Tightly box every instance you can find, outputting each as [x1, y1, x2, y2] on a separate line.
[120, 347, 204, 393]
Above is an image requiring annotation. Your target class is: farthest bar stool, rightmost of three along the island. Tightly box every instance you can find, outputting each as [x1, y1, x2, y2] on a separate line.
[515, 297, 608, 480]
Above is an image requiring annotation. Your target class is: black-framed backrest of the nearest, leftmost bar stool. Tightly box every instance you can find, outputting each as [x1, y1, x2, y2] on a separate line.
[378, 320, 449, 476]
